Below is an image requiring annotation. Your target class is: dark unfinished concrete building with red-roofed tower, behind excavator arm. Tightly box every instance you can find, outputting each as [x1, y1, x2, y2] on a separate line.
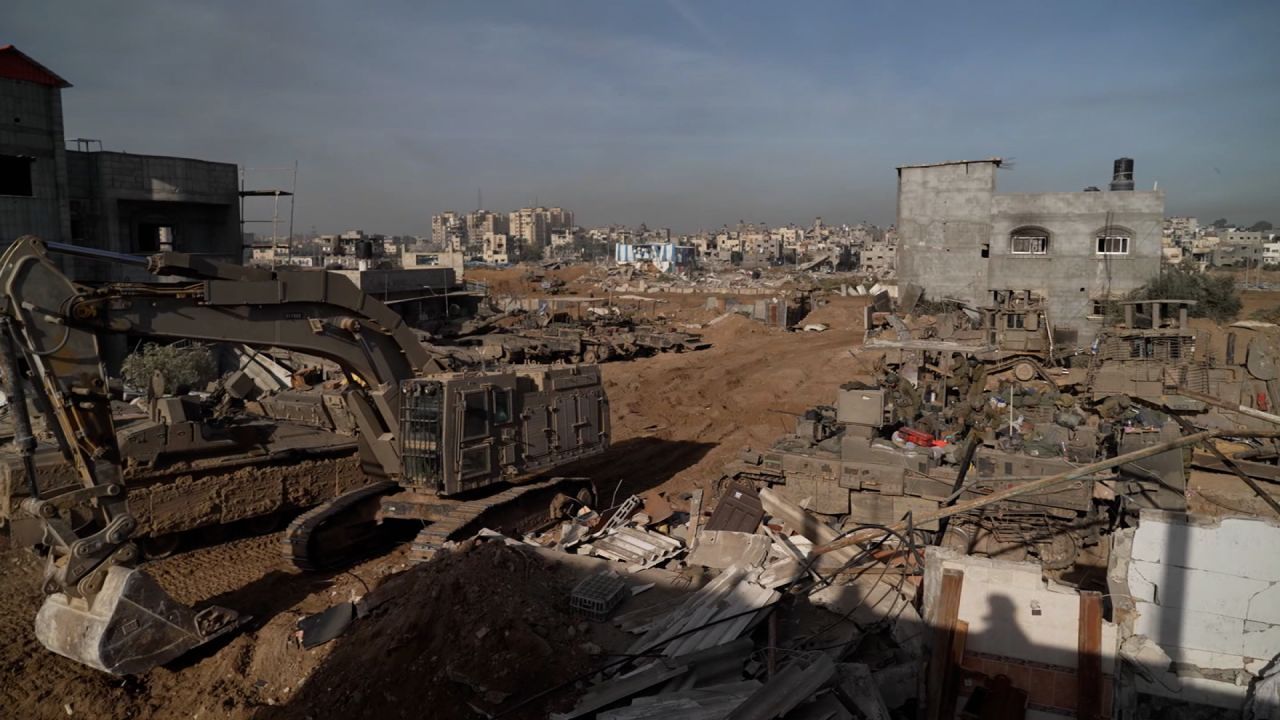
[0, 45, 243, 282]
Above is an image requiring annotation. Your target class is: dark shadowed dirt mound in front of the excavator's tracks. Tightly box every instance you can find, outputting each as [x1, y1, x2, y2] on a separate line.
[272, 542, 591, 719]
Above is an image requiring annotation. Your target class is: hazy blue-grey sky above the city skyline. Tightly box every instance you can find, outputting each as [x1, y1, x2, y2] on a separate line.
[0, 0, 1280, 234]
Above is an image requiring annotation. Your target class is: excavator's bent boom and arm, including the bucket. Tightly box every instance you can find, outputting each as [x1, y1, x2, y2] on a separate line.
[0, 236, 439, 674]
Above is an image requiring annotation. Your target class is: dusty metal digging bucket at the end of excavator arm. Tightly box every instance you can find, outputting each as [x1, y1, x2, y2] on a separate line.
[36, 566, 241, 675]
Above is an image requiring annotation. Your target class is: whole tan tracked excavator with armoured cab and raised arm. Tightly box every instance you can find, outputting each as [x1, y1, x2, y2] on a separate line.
[0, 236, 609, 675]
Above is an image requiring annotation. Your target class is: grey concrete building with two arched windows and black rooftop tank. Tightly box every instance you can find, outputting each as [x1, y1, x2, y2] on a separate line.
[896, 159, 1165, 345]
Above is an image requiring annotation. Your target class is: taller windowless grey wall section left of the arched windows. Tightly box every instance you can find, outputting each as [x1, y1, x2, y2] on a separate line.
[896, 161, 996, 302]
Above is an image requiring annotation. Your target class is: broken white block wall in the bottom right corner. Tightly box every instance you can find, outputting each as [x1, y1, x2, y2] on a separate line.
[1107, 510, 1280, 710]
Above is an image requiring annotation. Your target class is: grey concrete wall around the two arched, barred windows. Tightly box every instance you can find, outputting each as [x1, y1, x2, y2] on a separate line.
[993, 191, 1165, 343]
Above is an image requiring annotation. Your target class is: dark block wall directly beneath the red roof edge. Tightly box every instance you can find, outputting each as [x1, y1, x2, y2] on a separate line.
[0, 78, 70, 245]
